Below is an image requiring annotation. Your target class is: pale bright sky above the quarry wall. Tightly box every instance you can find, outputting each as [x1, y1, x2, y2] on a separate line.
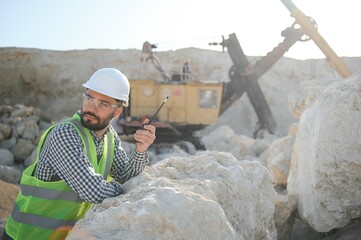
[0, 0, 361, 59]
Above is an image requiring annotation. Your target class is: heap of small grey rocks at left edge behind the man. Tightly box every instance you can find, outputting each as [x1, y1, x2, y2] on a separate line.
[0, 104, 51, 183]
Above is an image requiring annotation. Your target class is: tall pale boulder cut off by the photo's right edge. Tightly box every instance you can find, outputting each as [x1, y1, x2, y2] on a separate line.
[288, 73, 361, 232]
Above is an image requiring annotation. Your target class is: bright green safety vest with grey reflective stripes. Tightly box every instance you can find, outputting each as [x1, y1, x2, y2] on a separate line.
[5, 114, 114, 240]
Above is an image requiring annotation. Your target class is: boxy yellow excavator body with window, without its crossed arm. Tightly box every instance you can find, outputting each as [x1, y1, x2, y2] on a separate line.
[117, 42, 223, 137]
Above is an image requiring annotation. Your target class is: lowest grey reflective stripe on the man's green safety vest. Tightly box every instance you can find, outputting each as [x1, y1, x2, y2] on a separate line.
[11, 204, 77, 229]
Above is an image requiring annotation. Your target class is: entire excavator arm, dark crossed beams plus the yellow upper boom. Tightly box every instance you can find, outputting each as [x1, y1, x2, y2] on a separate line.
[209, 0, 352, 136]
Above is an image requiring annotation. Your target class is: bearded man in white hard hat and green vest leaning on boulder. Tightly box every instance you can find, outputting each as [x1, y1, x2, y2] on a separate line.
[1, 68, 156, 240]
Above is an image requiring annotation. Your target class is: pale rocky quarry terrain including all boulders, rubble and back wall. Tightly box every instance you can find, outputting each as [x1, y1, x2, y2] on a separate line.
[0, 48, 361, 240]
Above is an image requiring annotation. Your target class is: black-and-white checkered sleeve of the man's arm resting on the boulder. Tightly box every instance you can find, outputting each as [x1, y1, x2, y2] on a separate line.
[36, 124, 122, 203]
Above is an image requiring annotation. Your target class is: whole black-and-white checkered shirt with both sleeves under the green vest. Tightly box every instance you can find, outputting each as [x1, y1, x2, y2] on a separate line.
[35, 113, 148, 203]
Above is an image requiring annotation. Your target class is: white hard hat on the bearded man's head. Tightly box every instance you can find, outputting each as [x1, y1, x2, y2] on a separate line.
[83, 68, 130, 107]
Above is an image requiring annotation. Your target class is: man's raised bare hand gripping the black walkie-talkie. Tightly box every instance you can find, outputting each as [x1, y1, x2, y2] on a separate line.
[134, 119, 155, 152]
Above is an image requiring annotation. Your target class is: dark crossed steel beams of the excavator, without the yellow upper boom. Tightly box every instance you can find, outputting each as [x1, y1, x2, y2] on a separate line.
[215, 24, 305, 136]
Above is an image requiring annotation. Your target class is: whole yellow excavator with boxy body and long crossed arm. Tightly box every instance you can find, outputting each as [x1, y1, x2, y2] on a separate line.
[118, 0, 352, 140]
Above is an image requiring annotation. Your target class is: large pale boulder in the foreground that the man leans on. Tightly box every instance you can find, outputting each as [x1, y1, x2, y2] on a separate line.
[68, 152, 277, 240]
